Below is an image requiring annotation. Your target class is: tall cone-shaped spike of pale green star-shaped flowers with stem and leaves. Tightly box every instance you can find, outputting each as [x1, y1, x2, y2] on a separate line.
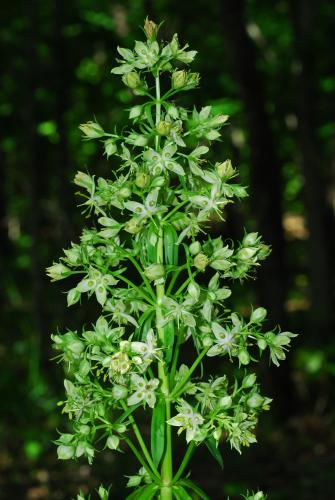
[47, 16, 295, 499]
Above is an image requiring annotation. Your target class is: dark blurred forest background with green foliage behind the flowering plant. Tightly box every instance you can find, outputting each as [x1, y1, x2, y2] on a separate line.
[0, 0, 335, 500]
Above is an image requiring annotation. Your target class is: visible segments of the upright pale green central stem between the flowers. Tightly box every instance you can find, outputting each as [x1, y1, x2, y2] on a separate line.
[155, 75, 173, 500]
